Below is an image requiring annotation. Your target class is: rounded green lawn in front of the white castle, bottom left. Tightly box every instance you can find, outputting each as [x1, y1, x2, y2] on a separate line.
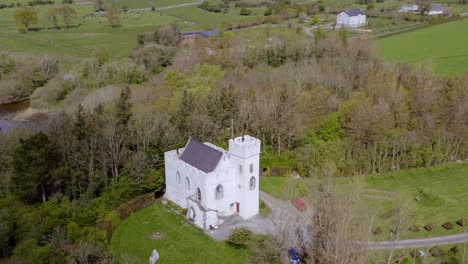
[111, 203, 249, 264]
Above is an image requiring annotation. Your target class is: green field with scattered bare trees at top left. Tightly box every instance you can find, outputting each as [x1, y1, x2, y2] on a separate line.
[0, 5, 183, 60]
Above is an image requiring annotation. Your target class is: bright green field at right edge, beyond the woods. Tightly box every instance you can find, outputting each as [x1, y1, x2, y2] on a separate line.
[378, 19, 468, 75]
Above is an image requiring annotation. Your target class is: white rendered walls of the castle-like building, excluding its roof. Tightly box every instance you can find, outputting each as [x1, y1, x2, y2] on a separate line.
[164, 136, 260, 228]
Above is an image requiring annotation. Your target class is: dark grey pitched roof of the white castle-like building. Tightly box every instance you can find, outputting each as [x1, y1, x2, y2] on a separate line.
[180, 138, 223, 173]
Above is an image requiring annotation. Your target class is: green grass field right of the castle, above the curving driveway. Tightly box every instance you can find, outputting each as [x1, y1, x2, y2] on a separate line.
[336, 163, 468, 240]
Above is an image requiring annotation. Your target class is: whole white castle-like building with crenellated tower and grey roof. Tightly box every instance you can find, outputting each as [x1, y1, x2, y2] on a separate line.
[164, 135, 261, 229]
